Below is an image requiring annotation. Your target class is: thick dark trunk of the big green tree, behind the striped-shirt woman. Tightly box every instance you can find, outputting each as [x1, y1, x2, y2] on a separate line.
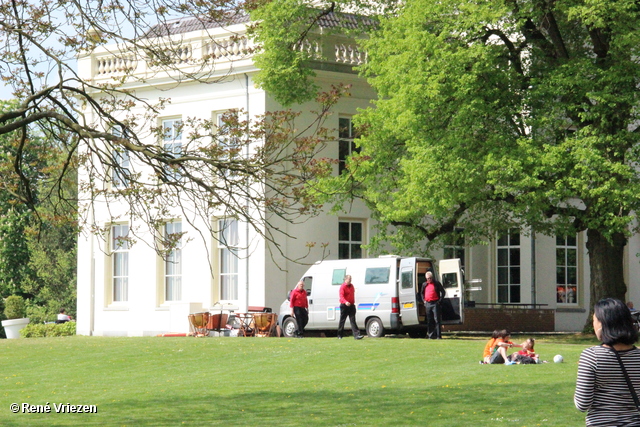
[584, 229, 627, 332]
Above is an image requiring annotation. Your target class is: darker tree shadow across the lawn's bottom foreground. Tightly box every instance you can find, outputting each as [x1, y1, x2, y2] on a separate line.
[2, 380, 584, 426]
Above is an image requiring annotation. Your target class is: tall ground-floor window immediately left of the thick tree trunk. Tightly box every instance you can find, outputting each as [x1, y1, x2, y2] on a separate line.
[556, 236, 578, 304]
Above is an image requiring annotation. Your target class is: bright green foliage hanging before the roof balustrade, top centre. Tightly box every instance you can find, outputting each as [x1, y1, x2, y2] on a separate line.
[250, 0, 380, 106]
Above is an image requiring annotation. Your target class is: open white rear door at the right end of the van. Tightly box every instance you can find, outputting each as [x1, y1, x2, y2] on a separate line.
[438, 258, 464, 325]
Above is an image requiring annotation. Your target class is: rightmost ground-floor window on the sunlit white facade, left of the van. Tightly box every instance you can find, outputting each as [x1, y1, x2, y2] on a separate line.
[218, 218, 240, 300]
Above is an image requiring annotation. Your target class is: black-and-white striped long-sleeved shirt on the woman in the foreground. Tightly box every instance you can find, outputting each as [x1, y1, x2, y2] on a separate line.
[573, 346, 640, 426]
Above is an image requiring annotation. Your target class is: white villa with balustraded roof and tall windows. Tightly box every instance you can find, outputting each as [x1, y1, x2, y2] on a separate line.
[77, 10, 640, 336]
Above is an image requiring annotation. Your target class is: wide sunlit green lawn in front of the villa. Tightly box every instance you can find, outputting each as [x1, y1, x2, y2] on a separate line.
[0, 337, 595, 427]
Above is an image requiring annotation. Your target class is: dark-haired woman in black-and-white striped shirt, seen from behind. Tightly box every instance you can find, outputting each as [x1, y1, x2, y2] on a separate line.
[574, 298, 640, 426]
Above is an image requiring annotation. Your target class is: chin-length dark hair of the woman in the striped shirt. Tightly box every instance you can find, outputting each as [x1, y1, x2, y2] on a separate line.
[593, 298, 638, 346]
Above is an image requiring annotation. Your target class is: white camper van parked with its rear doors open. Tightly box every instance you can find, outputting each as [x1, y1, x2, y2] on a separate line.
[278, 255, 464, 338]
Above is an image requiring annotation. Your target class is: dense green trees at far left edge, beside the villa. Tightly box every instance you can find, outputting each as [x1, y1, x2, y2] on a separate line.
[0, 101, 77, 321]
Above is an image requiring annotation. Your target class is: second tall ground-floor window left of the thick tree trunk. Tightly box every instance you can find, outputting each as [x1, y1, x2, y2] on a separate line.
[498, 229, 521, 303]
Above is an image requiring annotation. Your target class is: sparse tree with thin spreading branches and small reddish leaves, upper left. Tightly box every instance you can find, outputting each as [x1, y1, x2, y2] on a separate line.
[0, 0, 340, 260]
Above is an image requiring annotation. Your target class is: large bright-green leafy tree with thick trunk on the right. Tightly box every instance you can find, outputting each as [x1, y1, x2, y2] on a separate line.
[255, 0, 640, 330]
